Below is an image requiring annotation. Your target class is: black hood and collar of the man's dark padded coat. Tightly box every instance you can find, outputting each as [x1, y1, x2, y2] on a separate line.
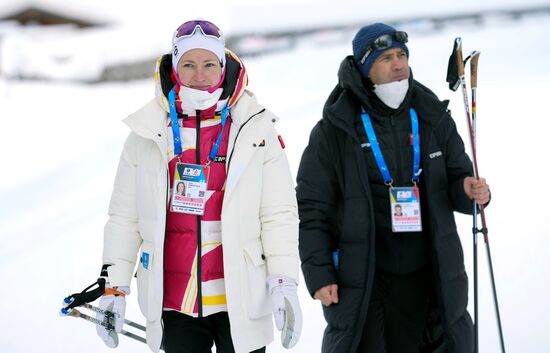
[323, 55, 449, 136]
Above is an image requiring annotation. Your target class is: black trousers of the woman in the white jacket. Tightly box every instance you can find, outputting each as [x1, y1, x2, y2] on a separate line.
[162, 311, 265, 353]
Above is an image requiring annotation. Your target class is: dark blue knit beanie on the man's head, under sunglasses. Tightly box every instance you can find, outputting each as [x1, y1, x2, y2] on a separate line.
[352, 23, 409, 78]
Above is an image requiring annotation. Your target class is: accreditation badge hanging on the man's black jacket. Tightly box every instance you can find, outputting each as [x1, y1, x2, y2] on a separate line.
[390, 187, 422, 233]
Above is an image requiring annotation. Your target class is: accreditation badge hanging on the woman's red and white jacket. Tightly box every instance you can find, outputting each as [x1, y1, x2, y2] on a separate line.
[170, 163, 210, 216]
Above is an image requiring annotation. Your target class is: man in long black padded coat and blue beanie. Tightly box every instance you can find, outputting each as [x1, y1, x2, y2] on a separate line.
[296, 23, 490, 353]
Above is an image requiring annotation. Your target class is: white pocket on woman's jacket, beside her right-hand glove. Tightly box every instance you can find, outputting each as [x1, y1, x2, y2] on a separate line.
[243, 239, 271, 319]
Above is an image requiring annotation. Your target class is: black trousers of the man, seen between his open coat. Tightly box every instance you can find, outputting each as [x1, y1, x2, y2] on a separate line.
[357, 266, 432, 353]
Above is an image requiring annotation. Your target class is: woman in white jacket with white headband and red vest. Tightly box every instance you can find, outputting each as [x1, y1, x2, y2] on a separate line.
[98, 20, 302, 353]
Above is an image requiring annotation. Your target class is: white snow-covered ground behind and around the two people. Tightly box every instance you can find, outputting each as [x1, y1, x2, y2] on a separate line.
[0, 5, 550, 353]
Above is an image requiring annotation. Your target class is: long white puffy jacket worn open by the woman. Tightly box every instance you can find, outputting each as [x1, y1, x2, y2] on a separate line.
[103, 91, 299, 353]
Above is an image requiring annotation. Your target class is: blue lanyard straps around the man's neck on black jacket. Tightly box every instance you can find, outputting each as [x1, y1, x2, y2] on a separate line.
[361, 108, 422, 187]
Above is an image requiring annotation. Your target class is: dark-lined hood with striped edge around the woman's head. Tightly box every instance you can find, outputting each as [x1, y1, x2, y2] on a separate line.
[155, 49, 248, 112]
